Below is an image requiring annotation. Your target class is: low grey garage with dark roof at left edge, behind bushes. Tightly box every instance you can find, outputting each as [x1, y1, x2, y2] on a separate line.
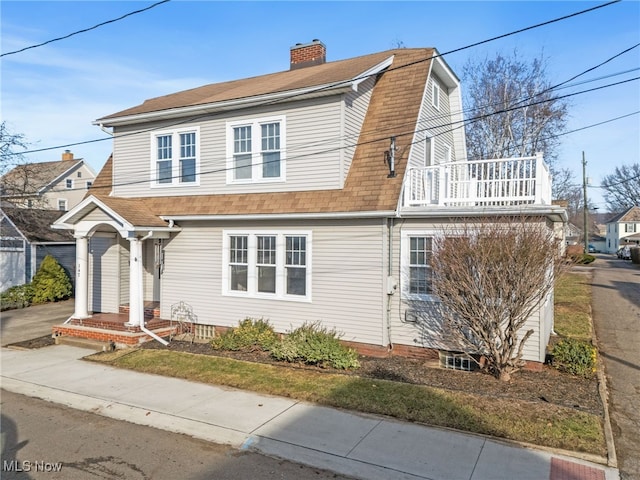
[0, 207, 76, 292]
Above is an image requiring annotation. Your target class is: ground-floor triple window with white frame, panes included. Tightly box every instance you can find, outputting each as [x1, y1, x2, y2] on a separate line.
[222, 231, 311, 301]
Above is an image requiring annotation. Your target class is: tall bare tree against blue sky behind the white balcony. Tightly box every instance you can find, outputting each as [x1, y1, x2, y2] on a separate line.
[462, 51, 568, 170]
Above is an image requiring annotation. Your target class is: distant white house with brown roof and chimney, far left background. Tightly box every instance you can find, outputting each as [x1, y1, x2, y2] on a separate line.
[0, 150, 96, 211]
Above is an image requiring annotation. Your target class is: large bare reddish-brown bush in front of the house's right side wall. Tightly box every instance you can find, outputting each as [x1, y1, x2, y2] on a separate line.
[433, 217, 565, 381]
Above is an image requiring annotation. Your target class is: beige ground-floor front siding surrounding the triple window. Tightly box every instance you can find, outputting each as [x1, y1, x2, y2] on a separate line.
[161, 220, 387, 345]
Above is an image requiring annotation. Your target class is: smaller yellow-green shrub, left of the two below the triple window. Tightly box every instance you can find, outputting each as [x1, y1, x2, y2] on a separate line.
[211, 318, 278, 352]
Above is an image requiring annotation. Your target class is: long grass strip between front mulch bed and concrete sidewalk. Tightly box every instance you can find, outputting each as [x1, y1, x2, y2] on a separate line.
[91, 350, 606, 455]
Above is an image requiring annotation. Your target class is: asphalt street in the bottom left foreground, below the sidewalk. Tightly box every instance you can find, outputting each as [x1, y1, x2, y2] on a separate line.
[0, 390, 347, 480]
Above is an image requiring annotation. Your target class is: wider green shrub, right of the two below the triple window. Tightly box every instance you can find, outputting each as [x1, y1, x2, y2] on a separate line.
[271, 323, 360, 369]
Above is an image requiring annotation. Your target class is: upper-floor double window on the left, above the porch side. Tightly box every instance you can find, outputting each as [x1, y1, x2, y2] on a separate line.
[151, 127, 200, 186]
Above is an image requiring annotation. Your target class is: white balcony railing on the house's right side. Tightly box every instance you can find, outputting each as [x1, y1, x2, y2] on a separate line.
[404, 154, 551, 207]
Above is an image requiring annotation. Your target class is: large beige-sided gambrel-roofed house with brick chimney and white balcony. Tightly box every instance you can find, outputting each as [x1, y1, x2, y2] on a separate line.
[55, 41, 566, 362]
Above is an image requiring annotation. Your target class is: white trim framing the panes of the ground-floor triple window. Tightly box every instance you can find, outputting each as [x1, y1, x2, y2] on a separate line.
[222, 229, 312, 303]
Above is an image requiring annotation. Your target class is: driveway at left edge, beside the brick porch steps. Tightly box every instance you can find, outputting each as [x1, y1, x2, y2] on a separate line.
[0, 299, 74, 346]
